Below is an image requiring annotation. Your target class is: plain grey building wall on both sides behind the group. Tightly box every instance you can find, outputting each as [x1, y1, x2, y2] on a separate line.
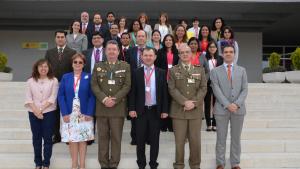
[0, 31, 262, 82]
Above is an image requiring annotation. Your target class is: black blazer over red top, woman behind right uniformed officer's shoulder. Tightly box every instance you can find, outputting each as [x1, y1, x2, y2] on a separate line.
[155, 48, 179, 70]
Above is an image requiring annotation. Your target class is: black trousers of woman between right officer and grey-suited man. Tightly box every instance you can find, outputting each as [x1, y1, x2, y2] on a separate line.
[204, 85, 216, 127]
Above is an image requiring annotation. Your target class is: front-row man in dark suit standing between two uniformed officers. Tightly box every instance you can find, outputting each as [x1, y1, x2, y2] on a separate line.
[129, 48, 168, 169]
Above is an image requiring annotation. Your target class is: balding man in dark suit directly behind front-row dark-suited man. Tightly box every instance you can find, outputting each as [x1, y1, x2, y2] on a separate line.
[126, 30, 147, 145]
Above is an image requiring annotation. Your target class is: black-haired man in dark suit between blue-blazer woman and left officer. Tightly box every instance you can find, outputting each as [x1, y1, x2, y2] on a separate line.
[82, 32, 106, 74]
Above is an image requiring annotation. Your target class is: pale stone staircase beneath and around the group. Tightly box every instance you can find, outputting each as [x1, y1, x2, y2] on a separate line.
[0, 82, 300, 169]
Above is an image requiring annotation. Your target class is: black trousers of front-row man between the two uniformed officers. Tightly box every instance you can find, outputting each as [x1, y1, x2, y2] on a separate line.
[136, 107, 161, 168]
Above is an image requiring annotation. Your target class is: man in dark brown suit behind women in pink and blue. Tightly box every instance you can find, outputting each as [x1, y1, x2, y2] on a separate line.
[45, 30, 76, 143]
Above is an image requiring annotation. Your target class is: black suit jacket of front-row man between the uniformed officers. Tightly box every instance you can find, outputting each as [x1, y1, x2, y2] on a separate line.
[128, 67, 169, 117]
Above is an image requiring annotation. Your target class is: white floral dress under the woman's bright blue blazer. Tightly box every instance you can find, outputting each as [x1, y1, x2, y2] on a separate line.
[61, 98, 95, 142]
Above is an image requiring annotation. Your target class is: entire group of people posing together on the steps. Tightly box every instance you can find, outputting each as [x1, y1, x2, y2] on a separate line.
[25, 12, 247, 169]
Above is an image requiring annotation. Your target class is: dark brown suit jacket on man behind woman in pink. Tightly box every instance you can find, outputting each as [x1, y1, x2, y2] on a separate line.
[45, 46, 76, 81]
